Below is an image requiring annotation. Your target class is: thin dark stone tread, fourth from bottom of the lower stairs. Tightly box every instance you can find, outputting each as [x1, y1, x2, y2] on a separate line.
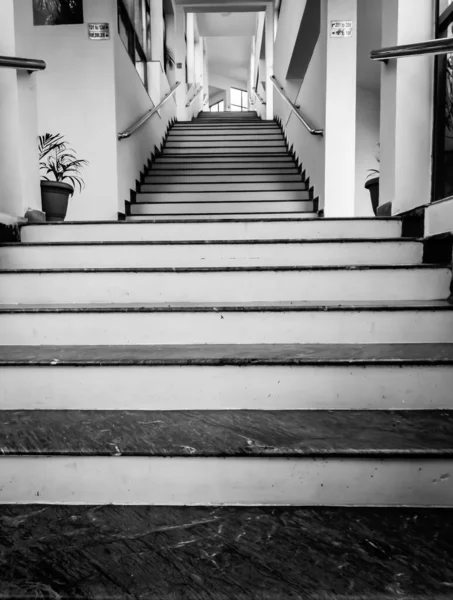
[0, 300, 453, 314]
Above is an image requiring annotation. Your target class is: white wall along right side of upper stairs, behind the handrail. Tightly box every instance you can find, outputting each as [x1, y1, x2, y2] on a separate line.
[274, 0, 327, 208]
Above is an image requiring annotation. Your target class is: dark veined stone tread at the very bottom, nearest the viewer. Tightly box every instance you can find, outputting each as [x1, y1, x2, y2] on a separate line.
[0, 505, 453, 600]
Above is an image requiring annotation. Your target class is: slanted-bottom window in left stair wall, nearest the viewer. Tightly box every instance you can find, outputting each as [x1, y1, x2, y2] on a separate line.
[118, 0, 151, 88]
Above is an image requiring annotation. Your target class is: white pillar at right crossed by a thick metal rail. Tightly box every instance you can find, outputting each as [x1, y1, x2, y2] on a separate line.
[379, 0, 435, 214]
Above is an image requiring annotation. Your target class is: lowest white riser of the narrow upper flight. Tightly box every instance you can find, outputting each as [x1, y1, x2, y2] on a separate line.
[131, 200, 313, 215]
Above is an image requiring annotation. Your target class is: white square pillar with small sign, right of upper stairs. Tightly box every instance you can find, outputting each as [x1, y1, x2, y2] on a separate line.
[324, 0, 358, 217]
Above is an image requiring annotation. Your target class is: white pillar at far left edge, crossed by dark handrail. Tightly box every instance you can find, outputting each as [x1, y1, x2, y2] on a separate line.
[0, 0, 41, 216]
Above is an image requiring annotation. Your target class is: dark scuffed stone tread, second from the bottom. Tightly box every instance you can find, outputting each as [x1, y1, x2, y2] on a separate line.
[0, 409, 453, 458]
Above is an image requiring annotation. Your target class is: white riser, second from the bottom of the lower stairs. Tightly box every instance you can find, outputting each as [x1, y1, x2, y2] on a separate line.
[0, 364, 453, 410]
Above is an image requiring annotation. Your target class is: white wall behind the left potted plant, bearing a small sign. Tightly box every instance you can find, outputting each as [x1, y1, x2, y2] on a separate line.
[30, 0, 118, 220]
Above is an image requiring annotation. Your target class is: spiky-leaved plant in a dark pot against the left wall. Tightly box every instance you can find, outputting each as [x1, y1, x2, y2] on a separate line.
[38, 133, 88, 221]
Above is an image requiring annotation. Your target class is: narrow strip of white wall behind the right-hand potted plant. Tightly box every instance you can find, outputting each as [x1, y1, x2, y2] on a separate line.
[355, 87, 380, 217]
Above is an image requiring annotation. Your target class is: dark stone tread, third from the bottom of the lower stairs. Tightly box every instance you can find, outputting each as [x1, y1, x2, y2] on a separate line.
[0, 343, 453, 366]
